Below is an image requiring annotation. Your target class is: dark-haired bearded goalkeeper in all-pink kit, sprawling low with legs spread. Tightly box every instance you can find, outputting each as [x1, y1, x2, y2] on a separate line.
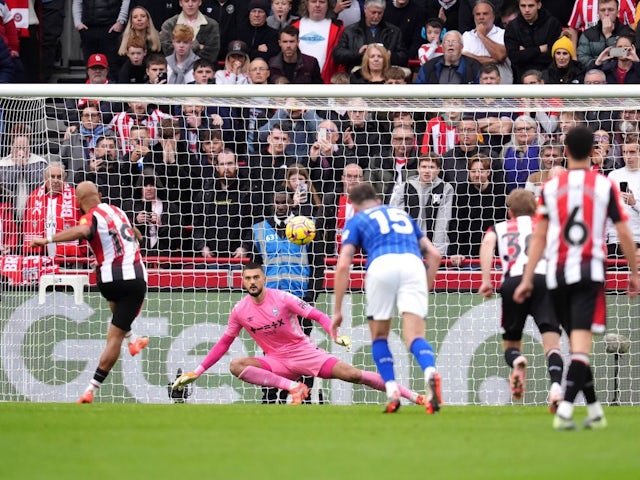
[173, 263, 424, 405]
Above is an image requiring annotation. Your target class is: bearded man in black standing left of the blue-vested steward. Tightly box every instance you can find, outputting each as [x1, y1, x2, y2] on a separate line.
[193, 149, 253, 258]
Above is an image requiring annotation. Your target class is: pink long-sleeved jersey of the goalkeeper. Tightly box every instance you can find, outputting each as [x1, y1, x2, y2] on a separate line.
[225, 288, 322, 355]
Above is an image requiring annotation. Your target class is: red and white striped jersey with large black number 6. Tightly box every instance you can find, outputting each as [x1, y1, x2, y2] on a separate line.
[538, 170, 627, 288]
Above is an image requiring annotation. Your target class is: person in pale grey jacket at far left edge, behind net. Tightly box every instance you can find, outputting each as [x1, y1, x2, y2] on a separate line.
[0, 123, 47, 221]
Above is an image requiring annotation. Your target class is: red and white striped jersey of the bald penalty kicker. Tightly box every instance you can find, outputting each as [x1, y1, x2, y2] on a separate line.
[80, 203, 147, 283]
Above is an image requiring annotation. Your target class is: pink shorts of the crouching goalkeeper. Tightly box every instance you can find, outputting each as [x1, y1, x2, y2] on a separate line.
[254, 345, 339, 380]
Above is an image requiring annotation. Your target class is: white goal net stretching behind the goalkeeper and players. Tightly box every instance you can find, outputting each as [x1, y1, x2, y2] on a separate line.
[0, 85, 640, 405]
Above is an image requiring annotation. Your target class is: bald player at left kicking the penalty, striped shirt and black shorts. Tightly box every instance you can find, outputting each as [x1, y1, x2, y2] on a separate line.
[31, 182, 149, 403]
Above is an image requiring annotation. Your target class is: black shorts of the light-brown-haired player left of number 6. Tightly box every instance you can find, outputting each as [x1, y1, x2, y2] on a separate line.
[500, 275, 560, 341]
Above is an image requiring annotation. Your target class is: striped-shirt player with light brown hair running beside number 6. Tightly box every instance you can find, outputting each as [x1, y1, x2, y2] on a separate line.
[478, 188, 564, 413]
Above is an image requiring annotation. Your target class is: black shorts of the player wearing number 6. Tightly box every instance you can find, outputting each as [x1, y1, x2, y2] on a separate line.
[551, 280, 607, 334]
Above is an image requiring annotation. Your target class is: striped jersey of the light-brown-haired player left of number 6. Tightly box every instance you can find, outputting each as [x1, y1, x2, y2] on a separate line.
[492, 215, 547, 281]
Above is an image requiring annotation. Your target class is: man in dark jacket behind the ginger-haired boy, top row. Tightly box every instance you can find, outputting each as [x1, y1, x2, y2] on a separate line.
[160, 0, 220, 63]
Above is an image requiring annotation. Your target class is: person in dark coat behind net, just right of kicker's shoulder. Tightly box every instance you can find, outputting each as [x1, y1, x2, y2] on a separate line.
[122, 169, 180, 257]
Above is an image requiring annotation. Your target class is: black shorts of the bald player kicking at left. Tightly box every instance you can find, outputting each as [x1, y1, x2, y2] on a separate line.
[98, 279, 147, 332]
